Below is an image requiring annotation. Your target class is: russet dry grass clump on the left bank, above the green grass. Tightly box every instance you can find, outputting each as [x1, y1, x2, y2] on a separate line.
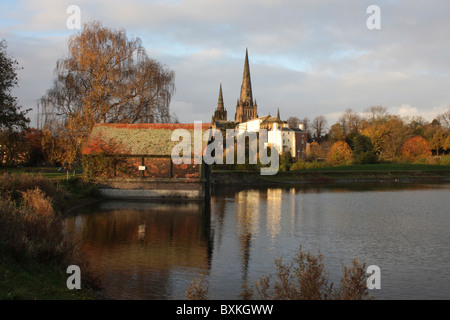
[0, 174, 74, 261]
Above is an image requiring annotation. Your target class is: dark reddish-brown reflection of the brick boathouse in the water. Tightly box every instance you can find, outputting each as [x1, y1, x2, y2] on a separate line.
[66, 201, 212, 299]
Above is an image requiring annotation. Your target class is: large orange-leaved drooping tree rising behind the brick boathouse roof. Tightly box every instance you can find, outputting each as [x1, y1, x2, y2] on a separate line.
[40, 22, 175, 163]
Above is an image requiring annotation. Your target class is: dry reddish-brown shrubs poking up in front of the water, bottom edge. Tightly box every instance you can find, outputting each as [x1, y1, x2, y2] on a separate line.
[186, 247, 372, 300]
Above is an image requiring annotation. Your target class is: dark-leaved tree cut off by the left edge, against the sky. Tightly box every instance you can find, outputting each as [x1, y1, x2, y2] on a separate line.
[0, 40, 30, 130]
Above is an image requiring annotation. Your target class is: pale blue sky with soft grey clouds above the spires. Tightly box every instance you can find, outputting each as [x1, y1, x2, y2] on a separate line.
[0, 0, 450, 125]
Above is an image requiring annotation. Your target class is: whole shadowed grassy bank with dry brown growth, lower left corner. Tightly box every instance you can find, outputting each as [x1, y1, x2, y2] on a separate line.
[0, 174, 102, 300]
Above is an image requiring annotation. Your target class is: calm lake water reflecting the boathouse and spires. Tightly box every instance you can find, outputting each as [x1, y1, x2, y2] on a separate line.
[66, 183, 450, 300]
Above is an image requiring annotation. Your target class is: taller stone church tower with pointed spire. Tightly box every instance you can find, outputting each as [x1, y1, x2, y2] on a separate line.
[235, 49, 258, 122]
